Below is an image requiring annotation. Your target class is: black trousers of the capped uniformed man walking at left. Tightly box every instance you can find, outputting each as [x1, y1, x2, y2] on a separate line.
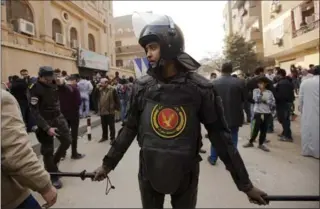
[36, 115, 71, 178]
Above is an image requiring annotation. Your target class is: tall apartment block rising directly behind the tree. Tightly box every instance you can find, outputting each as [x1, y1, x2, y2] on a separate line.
[224, 0, 274, 65]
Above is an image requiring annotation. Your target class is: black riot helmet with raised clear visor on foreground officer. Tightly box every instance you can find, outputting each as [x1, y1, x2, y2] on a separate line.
[132, 13, 184, 60]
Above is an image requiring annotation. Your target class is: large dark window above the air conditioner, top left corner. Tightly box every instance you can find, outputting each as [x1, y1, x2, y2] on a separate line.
[5, 0, 34, 32]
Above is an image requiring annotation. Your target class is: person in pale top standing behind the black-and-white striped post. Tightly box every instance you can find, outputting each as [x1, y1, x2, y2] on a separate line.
[77, 76, 93, 118]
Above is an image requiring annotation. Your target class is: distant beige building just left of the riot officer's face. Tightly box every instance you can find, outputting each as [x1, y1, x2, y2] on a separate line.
[114, 15, 146, 77]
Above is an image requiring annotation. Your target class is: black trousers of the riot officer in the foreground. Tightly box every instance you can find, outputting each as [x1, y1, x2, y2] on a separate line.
[139, 163, 199, 209]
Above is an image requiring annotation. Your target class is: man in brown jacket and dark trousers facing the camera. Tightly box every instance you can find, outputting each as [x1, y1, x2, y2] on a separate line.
[98, 78, 120, 143]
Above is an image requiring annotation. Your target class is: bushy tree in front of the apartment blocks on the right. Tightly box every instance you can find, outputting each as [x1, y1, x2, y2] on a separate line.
[223, 34, 261, 73]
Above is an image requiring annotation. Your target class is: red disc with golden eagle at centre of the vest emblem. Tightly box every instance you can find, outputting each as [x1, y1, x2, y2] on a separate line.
[157, 108, 179, 131]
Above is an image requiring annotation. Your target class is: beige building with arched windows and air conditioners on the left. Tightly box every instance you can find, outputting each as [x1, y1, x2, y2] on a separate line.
[1, 0, 115, 81]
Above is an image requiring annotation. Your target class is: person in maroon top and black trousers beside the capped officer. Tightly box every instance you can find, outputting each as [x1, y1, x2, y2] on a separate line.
[57, 76, 85, 160]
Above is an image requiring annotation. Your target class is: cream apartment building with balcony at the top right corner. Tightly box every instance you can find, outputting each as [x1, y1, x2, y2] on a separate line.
[262, 0, 319, 72]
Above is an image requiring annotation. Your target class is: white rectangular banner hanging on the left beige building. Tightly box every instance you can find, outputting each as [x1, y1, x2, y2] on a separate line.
[78, 48, 109, 71]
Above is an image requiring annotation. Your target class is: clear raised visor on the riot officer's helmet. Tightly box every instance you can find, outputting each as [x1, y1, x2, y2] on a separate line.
[132, 12, 174, 39]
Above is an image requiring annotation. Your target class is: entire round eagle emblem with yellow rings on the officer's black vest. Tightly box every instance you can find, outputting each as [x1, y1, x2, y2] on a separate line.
[151, 104, 187, 139]
